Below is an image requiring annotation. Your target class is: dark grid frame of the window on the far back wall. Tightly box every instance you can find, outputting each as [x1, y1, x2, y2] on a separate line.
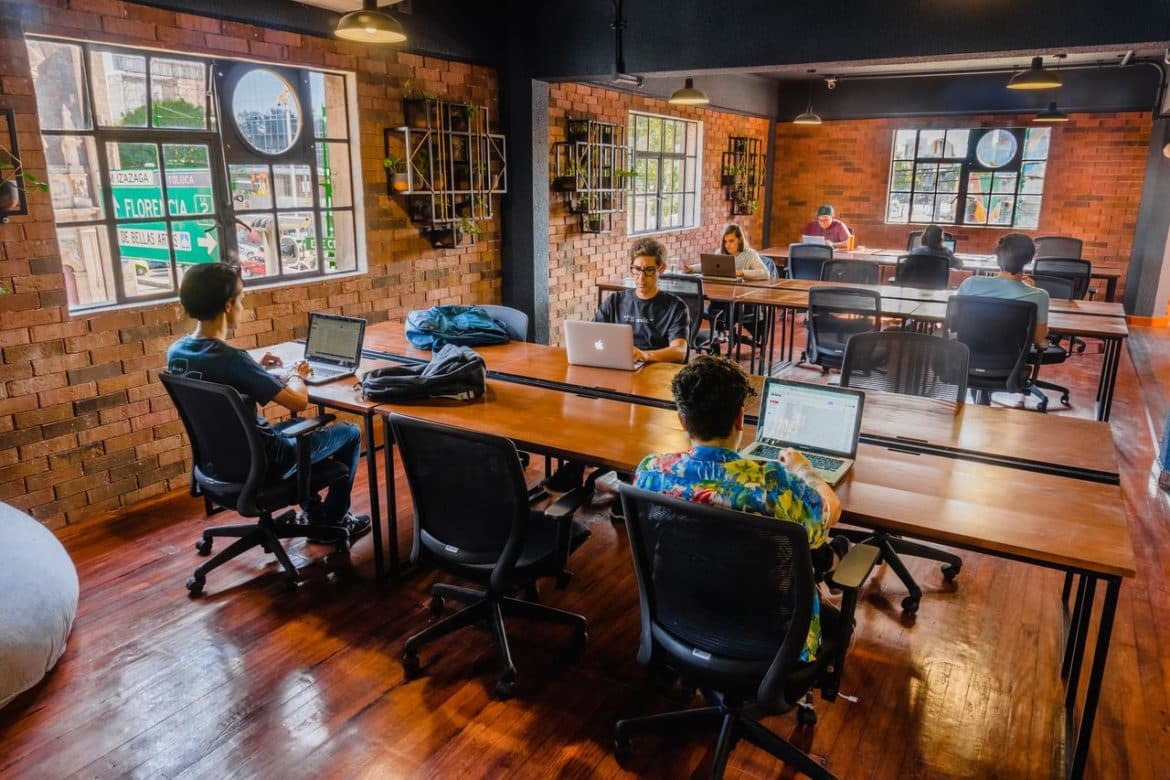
[883, 126, 1052, 230]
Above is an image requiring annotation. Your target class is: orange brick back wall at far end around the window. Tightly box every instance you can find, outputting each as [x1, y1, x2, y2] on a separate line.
[771, 112, 1151, 290]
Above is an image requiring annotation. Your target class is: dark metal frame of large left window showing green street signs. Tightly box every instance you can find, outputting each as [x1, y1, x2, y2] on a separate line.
[25, 34, 365, 313]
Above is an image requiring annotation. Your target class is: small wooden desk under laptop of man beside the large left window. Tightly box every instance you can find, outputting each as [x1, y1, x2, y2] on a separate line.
[249, 341, 397, 580]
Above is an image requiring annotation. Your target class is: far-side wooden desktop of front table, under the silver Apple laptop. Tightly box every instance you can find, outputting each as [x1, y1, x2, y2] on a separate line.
[366, 323, 1119, 484]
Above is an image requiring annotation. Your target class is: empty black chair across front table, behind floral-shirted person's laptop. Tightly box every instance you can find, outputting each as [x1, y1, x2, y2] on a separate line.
[832, 331, 970, 615]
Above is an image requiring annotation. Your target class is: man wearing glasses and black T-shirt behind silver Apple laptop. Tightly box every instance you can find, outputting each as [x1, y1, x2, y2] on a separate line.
[593, 239, 690, 363]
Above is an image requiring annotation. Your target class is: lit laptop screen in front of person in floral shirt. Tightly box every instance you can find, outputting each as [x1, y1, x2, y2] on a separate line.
[756, 379, 865, 457]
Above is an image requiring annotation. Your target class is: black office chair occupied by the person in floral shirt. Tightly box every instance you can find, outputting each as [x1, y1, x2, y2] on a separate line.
[614, 484, 878, 778]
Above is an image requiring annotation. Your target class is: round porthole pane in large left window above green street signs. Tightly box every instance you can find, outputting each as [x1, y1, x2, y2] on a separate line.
[232, 68, 301, 154]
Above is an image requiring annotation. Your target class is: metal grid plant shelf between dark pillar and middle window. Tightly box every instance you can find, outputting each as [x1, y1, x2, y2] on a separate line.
[551, 117, 629, 233]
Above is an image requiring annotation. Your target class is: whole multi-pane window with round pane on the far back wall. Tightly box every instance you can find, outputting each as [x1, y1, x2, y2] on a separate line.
[886, 127, 1052, 229]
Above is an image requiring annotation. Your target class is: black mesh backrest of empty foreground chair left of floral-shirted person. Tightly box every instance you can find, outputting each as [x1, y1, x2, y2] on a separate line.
[391, 414, 528, 564]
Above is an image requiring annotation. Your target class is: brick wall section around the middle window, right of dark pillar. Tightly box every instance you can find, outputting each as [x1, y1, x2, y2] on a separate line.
[549, 84, 768, 344]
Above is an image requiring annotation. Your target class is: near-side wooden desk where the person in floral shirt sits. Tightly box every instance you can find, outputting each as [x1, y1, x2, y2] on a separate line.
[384, 380, 1135, 778]
